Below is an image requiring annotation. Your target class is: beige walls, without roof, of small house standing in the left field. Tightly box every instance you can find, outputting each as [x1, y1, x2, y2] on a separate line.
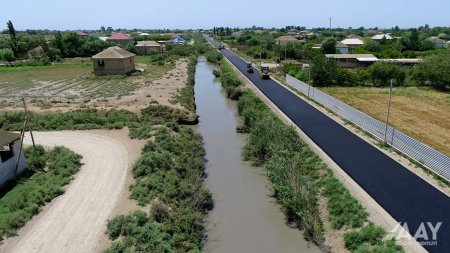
[92, 56, 135, 76]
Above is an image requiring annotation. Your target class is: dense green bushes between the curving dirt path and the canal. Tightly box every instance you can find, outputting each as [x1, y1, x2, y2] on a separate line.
[105, 125, 214, 252]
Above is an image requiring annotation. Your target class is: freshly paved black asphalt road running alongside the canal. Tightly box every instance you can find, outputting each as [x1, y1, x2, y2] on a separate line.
[208, 38, 450, 252]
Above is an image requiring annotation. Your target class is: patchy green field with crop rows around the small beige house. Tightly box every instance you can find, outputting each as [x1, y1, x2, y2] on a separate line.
[0, 57, 175, 109]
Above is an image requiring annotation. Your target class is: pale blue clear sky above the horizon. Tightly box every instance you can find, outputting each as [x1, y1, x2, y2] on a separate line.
[0, 0, 450, 30]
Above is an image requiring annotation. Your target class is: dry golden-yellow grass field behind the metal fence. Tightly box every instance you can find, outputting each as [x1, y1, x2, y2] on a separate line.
[321, 87, 450, 155]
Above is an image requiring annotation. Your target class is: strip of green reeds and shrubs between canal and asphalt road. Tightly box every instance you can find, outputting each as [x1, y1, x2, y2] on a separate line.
[213, 56, 403, 252]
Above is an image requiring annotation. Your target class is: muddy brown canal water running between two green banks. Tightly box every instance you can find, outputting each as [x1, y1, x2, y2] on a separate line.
[195, 57, 320, 253]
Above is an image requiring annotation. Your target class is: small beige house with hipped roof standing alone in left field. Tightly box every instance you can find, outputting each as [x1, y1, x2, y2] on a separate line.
[92, 46, 135, 76]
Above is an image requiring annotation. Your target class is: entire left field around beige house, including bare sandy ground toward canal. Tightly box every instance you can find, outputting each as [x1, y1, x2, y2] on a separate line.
[0, 56, 187, 112]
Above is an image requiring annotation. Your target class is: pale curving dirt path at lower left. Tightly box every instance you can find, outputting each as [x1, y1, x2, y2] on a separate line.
[0, 130, 142, 253]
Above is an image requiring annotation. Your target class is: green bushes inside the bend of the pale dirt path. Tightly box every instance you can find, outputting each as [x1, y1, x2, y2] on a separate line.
[0, 146, 81, 241]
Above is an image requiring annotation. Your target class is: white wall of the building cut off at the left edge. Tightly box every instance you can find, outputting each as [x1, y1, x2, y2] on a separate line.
[0, 140, 27, 188]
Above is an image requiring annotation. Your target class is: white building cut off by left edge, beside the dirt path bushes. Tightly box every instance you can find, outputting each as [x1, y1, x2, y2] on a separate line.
[0, 130, 27, 187]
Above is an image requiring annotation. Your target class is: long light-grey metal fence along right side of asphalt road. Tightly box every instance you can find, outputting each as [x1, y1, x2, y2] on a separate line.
[286, 75, 450, 181]
